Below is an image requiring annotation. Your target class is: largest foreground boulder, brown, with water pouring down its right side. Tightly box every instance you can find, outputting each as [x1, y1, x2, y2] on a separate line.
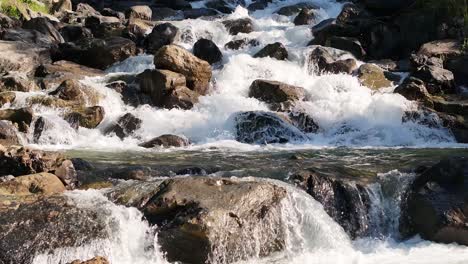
[142, 177, 286, 263]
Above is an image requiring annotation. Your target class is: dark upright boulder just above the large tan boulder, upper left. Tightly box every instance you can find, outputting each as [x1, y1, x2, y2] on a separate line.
[145, 23, 179, 54]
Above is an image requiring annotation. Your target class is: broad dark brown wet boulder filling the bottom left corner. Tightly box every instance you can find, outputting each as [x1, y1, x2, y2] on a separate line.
[0, 196, 107, 263]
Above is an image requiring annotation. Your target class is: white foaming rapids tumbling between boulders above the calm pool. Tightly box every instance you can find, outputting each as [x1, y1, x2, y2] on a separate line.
[0, 0, 459, 150]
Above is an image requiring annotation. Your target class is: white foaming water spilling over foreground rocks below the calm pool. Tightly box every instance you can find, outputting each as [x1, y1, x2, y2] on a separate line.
[33, 170, 468, 264]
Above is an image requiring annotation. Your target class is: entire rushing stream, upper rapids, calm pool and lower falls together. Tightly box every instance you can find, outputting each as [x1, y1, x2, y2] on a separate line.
[4, 0, 468, 264]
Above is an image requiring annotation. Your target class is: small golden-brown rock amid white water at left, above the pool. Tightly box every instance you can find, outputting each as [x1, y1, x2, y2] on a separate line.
[64, 106, 105, 129]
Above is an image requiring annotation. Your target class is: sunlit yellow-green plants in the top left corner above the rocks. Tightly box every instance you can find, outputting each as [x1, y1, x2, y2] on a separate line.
[0, 0, 49, 18]
